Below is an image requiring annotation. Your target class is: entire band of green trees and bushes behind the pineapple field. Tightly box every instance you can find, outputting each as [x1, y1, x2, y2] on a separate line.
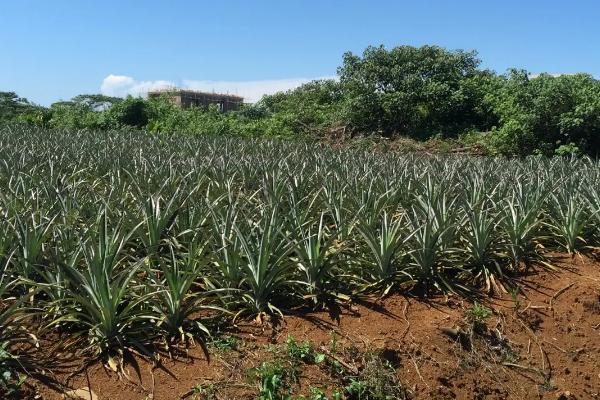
[0, 46, 600, 155]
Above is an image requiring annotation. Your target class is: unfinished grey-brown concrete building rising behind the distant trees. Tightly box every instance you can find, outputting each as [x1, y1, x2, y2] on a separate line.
[148, 88, 244, 112]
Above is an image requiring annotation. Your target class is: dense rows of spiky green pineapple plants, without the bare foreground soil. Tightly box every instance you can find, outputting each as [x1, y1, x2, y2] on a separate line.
[0, 127, 600, 391]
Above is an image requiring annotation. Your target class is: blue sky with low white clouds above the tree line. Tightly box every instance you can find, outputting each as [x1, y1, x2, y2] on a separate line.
[0, 0, 600, 105]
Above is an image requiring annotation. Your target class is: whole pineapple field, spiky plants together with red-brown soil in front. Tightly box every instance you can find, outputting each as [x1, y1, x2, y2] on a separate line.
[0, 127, 600, 399]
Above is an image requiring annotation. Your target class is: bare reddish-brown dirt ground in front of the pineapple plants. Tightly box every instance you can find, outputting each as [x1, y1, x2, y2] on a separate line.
[28, 255, 600, 400]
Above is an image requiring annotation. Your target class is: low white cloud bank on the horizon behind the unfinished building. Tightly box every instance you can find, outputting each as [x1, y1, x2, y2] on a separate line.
[100, 74, 335, 103]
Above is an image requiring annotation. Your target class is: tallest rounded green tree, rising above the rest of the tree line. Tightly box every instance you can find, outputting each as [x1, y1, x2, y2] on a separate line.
[338, 46, 482, 138]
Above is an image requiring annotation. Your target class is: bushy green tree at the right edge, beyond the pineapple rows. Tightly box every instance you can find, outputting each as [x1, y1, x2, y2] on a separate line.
[489, 70, 600, 155]
